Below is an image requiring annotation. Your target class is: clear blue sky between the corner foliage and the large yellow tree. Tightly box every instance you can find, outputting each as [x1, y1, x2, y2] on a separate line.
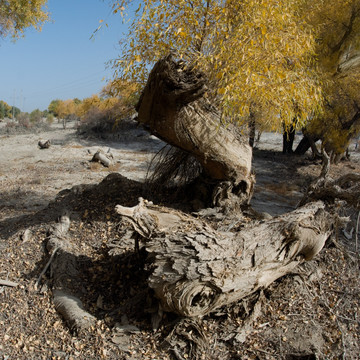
[0, 0, 126, 112]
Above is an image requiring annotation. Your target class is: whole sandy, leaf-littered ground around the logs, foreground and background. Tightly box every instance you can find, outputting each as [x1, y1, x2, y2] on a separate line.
[0, 124, 360, 360]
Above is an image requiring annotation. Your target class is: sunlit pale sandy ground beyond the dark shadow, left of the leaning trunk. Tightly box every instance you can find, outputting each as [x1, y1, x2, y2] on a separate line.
[0, 123, 163, 219]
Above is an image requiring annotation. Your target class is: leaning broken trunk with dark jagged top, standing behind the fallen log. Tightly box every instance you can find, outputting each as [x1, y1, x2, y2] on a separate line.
[136, 55, 254, 205]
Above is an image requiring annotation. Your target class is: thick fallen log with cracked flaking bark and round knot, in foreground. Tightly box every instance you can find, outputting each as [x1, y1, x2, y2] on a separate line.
[116, 199, 332, 317]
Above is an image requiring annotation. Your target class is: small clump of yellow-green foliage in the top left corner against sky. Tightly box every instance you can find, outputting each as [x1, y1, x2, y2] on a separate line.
[0, 0, 49, 40]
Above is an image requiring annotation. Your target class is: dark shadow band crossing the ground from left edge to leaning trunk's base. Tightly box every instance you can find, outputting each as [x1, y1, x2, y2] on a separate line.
[0, 173, 190, 240]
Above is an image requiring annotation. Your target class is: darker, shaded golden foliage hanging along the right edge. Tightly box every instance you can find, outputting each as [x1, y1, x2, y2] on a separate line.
[300, 0, 360, 153]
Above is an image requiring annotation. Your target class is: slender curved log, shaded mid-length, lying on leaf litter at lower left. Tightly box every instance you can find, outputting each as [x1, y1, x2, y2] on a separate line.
[46, 215, 96, 332]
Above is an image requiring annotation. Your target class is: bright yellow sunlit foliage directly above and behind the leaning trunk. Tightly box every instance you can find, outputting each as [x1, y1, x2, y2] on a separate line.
[113, 0, 321, 128]
